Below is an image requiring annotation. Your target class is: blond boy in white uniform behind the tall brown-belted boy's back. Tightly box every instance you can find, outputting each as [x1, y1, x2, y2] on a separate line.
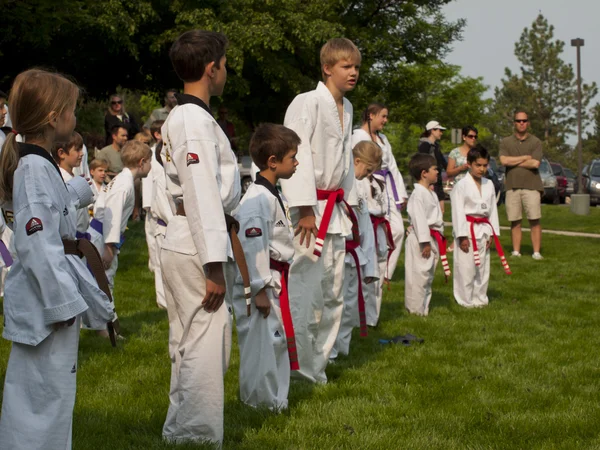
[88, 141, 152, 334]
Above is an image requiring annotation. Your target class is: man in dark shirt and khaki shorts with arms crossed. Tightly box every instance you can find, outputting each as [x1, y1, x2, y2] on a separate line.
[500, 110, 544, 259]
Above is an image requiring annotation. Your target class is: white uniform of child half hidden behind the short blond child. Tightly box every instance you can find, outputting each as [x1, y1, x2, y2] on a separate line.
[364, 174, 394, 327]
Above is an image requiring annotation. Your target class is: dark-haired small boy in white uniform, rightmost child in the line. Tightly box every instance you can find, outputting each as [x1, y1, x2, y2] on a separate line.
[450, 145, 511, 308]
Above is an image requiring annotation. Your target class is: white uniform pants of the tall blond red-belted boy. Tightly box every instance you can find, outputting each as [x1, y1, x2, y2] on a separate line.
[289, 234, 346, 383]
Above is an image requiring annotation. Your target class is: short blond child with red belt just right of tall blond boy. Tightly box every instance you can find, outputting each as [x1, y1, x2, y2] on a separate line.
[329, 141, 382, 359]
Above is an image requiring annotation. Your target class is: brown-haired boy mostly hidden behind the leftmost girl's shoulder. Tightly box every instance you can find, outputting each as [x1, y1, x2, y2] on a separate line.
[52, 131, 90, 239]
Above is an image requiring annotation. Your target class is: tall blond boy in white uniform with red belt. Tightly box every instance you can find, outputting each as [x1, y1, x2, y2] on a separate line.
[281, 38, 361, 383]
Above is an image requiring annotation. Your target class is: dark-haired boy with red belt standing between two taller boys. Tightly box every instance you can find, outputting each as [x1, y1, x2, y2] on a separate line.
[233, 123, 300, 411]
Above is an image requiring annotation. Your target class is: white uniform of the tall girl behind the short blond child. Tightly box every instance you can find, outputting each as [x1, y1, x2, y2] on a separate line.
[352, 128, 408, 279]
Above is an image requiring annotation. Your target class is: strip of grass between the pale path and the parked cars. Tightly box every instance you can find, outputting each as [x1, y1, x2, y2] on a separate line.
[444, 201, 600, 233]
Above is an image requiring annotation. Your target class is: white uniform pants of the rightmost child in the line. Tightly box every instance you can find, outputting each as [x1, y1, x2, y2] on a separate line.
[453, 236, 490, 308]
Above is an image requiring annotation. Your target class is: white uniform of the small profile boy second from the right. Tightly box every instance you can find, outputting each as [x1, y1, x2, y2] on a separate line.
[404, 183, 444, 316]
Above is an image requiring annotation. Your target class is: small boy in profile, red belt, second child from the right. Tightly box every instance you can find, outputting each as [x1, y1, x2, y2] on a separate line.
[404, 153, 446, 316]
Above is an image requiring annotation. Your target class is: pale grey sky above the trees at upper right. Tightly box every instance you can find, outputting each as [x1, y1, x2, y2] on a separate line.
[443, 0, 600, 141]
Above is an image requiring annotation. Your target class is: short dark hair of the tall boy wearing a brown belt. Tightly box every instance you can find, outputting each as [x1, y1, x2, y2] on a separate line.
[169, 30, 227, 83]
